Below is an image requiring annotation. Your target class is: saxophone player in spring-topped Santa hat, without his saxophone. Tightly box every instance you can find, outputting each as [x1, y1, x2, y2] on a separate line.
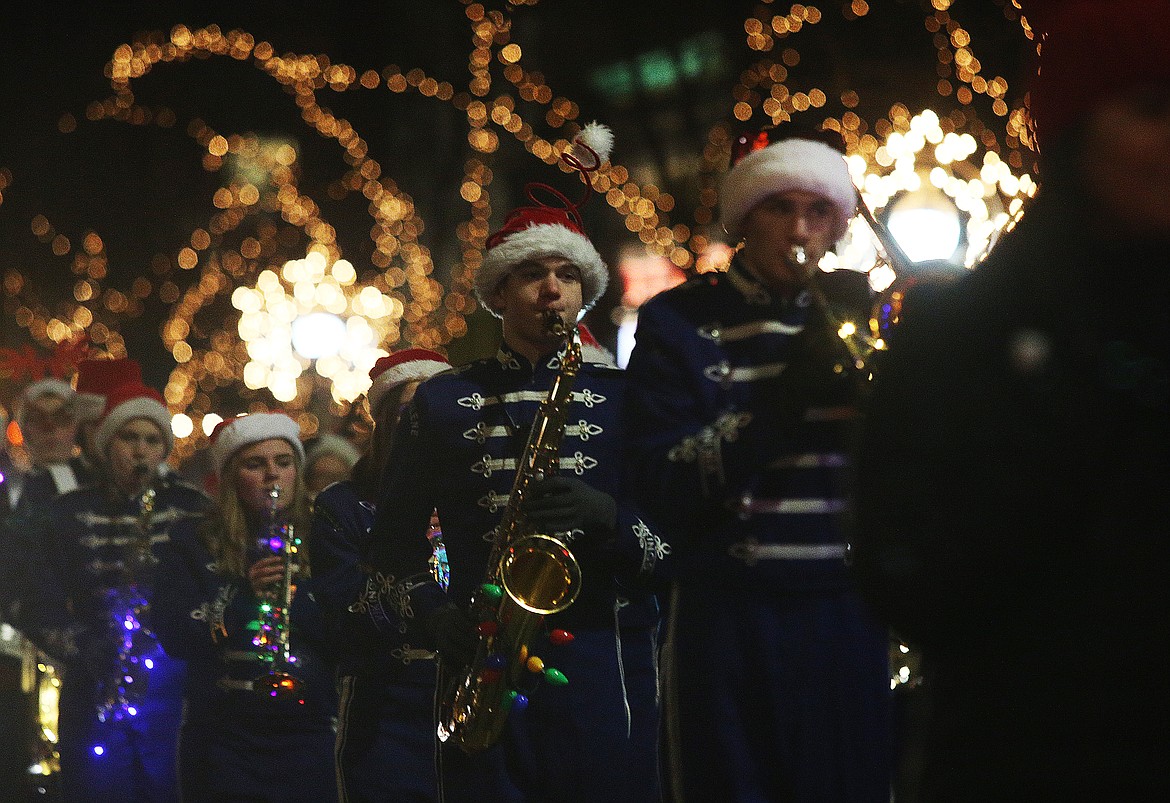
[358, 125, 666, 803]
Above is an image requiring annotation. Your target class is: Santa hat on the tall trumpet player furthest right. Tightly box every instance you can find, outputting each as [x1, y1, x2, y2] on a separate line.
[720, 126, 858, 240]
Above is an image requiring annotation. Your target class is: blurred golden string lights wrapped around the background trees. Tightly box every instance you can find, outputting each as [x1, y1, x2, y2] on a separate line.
[0, 0, 1035, 459]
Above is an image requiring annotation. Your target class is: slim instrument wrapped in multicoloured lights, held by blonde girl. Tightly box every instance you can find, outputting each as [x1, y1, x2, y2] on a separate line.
[252, 486, 304, 699]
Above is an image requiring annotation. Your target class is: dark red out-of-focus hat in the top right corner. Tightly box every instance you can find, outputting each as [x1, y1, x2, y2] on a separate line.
[1021, 0, 1170, 155]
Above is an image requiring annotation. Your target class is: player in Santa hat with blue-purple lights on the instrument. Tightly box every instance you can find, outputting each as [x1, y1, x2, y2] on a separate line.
[11, 380, 207, 801]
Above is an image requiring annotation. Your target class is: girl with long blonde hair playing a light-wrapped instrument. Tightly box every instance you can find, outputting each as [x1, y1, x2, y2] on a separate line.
[153, 413, 337, 803]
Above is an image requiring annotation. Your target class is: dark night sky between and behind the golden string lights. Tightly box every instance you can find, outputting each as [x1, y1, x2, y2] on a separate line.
[0, 0, 1031, 403]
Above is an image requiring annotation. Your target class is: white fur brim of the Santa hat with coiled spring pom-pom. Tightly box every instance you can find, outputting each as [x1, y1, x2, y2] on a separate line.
[475, 224, 610, 317]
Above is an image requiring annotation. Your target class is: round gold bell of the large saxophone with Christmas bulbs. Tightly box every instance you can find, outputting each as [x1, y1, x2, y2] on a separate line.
[500, 534, 581, 616]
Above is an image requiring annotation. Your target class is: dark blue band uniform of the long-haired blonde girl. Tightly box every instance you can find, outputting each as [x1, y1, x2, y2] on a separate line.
[148, 512, 337, 803]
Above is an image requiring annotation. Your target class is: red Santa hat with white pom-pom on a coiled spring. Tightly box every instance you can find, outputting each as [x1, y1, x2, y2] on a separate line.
[475, 122, 613, 317]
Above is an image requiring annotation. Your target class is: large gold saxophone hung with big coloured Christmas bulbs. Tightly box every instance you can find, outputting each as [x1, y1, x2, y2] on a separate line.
[438, 310, 581, 754]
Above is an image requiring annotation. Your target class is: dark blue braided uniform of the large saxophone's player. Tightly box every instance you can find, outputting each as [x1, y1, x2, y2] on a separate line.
[357, 345, 666, 801]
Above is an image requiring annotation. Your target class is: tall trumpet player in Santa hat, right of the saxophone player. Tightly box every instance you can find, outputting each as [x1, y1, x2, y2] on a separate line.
[627, 124, 889, 803]
